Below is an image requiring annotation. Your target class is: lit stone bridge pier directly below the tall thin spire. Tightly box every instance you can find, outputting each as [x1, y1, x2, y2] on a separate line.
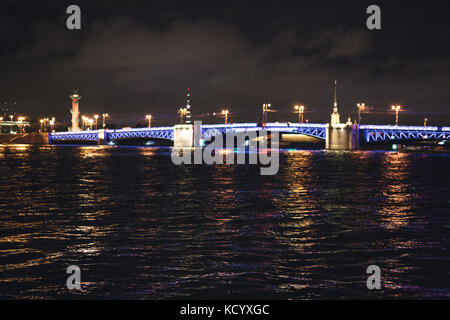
[325, 123, 359, 150]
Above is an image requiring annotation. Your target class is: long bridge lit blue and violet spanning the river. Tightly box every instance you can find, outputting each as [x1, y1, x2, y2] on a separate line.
[49, 123, 450, 149]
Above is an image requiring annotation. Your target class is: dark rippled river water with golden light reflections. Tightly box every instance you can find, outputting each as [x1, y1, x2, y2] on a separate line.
[0, 146, 450, 299]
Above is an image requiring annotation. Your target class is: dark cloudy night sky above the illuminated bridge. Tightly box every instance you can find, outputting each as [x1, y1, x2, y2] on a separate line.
[0, 0, 450, 125]
